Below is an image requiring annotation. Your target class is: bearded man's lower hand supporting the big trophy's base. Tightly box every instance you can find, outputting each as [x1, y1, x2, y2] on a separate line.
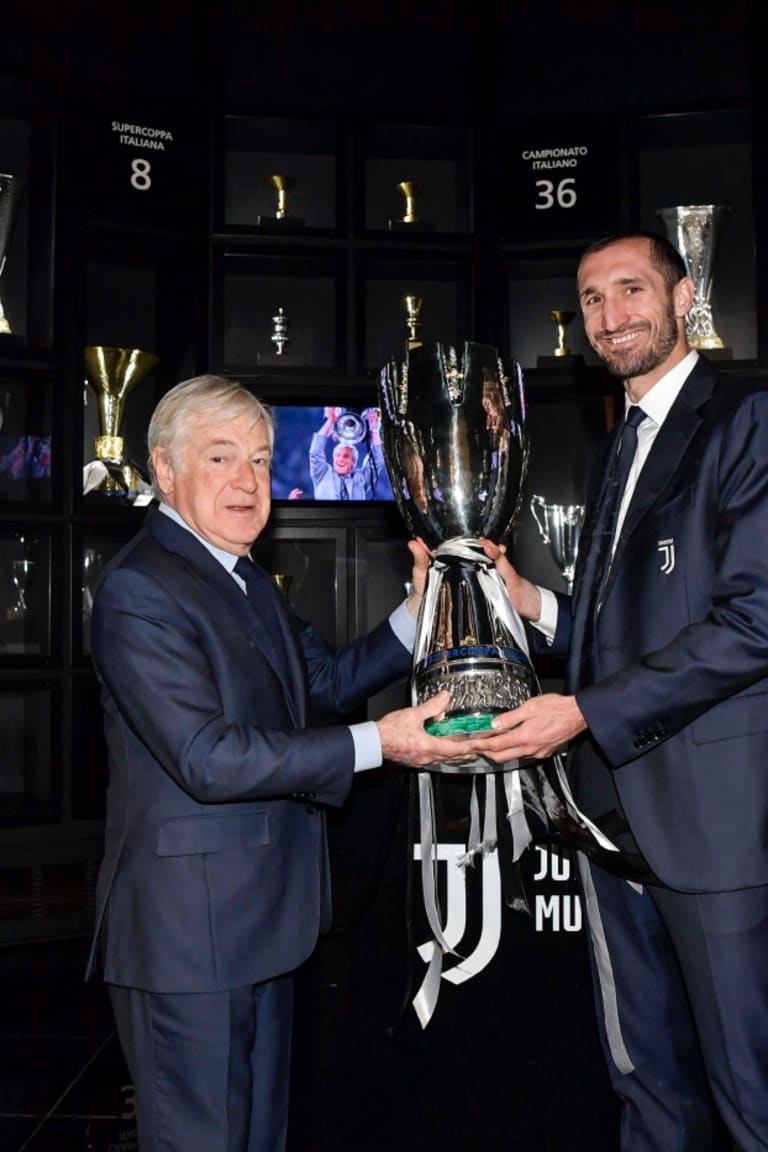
[470, 692, 587, 764]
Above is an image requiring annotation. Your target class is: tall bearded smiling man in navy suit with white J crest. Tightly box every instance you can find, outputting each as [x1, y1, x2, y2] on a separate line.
[473, 233, 768, 1152]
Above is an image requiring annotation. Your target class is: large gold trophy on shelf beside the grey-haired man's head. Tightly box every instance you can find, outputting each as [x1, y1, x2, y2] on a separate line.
[85, 344, 159, 495]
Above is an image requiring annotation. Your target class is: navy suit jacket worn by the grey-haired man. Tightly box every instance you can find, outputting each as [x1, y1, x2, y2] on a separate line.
[89, 511, 411, 992]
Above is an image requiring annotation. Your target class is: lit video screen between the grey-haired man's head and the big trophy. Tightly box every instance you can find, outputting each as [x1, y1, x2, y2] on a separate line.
[272, 404, 395, 503]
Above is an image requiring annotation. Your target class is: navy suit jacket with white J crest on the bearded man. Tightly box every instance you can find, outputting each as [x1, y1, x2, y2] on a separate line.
[545, 357, 768, 892]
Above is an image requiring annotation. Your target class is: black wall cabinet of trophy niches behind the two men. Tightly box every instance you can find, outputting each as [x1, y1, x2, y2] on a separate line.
[0, 81, 768, 941]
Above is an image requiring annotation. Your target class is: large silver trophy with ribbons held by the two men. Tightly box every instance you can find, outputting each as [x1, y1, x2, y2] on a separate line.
[380, 343, 538, 773]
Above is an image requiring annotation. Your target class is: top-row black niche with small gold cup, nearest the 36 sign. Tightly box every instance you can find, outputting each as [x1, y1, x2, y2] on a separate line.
[356, 124, 472, 235]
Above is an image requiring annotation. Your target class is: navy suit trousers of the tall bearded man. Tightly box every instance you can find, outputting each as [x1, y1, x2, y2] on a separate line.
[579, 857, 768, 1152]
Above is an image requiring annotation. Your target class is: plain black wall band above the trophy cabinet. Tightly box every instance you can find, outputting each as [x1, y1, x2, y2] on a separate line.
[0, 0, 766, 114]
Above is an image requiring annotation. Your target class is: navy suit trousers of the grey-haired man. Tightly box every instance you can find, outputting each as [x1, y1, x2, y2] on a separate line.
[109, 976, 294, 1152]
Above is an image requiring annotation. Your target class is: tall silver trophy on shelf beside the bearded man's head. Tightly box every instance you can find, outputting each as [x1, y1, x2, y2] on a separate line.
[659, 204, 729, 349]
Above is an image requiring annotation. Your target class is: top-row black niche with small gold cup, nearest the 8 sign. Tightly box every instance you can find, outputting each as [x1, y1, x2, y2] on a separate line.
[214, 115, 343, 236]
